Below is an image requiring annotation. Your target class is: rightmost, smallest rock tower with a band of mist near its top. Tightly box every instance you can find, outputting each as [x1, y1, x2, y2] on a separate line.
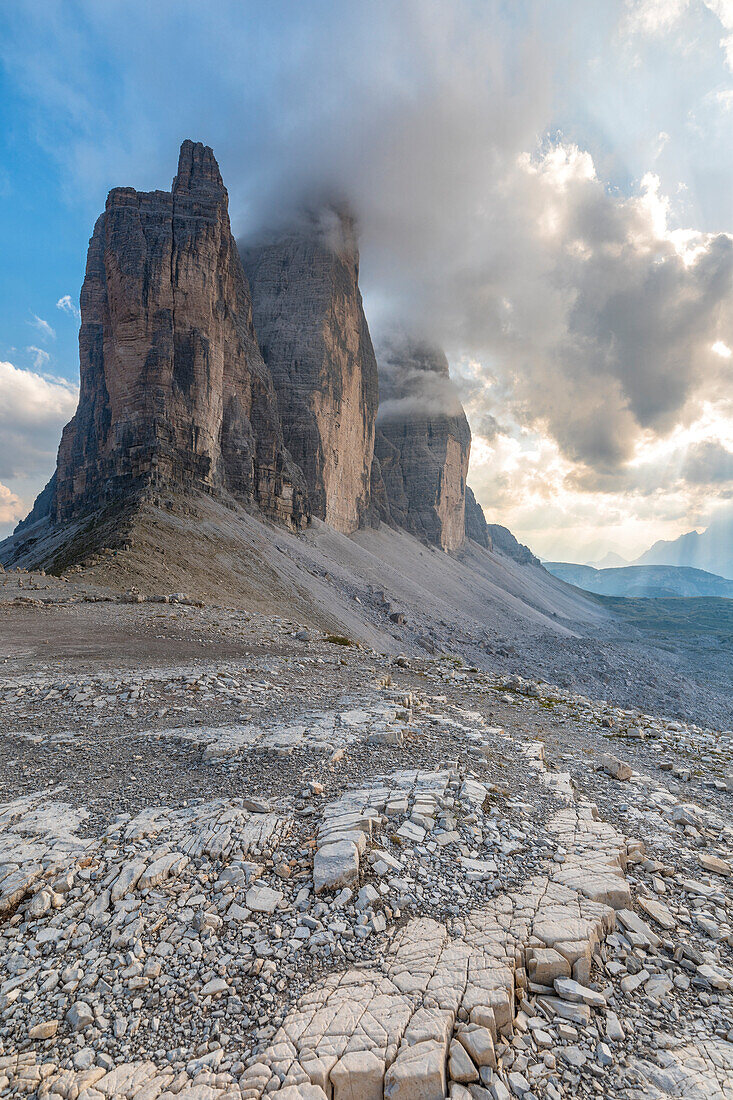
[375, 338, 471, 550]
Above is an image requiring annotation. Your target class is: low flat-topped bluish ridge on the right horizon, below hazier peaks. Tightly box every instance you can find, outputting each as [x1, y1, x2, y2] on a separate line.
[545, 561, 733, 600]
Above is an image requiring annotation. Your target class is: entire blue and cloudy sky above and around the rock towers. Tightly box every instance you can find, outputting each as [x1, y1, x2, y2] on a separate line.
[0, 0, 733, 559]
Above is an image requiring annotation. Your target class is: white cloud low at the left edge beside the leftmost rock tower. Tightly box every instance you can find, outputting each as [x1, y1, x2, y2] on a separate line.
[0, 361, 78, 481]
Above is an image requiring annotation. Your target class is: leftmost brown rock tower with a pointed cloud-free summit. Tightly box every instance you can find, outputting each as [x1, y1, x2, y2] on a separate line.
[50, 141, 306, 526]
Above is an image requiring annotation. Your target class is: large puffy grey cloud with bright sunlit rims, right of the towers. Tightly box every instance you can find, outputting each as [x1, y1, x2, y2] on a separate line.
[433, 144, 733, 471]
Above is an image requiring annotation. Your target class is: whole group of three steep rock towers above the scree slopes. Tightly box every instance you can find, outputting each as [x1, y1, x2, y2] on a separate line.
[9, 141, 490, 567]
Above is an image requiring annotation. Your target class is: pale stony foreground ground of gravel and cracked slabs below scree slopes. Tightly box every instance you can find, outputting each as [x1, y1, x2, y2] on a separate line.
[0, 579, 733, 1100]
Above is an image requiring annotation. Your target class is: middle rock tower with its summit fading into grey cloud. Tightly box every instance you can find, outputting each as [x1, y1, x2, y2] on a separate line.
[241, 209, 379, 534]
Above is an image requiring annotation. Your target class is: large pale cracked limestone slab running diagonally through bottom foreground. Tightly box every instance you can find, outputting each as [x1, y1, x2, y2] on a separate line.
[242, 803, 625, 1100]
